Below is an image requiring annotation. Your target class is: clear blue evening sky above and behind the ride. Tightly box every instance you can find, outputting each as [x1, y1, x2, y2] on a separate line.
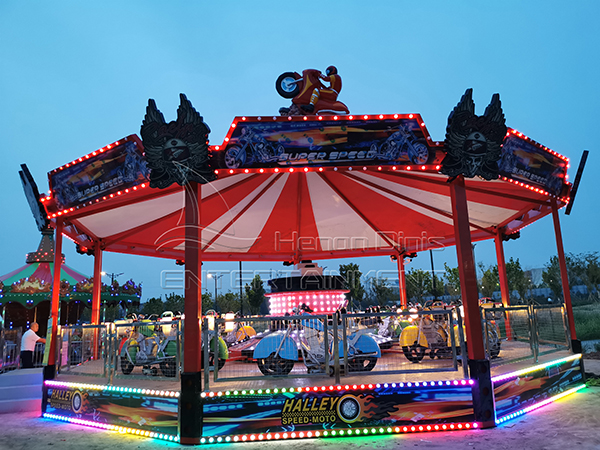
[0, 0, 600, 299]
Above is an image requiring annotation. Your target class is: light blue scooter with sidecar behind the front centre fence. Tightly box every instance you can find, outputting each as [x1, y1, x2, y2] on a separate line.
[253, 313, 381, 375]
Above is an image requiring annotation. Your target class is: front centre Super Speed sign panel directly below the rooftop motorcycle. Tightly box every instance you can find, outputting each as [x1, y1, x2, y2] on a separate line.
[211, 118, 444, 169]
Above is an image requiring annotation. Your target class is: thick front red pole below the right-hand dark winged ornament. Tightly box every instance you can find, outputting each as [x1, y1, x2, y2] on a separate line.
[450, 175, 485, 360]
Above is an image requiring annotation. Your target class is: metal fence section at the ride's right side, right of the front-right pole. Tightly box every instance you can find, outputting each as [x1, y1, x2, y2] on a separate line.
[480, 305, 571, 366]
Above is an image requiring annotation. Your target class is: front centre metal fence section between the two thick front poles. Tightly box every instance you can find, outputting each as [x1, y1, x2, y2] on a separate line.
[203, 309, 467, 388]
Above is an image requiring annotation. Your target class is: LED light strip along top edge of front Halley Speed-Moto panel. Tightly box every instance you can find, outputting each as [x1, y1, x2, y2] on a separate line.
[200, 380, 475, 398]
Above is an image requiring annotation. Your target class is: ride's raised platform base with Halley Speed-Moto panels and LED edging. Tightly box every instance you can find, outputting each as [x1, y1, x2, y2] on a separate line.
[43, 346, 585, 444]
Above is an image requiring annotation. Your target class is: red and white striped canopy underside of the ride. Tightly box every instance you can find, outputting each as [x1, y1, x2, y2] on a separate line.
[54, 166, 564, 261]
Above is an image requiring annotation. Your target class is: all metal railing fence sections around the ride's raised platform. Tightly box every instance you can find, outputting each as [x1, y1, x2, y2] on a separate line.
[0, 305, 570, 389]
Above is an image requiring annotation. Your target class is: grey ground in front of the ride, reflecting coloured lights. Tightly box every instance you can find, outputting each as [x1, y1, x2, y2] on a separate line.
[0, 387, 600, 450]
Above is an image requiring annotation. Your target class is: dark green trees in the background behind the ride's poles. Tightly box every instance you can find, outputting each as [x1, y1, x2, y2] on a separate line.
[134, 252, 600, 316]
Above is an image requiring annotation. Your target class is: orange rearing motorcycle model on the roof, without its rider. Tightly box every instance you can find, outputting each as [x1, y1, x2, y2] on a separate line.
[275, 69, 350, 116]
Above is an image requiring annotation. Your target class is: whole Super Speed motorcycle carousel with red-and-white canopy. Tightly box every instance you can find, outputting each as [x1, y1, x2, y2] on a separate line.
[18, 67, 585, 444]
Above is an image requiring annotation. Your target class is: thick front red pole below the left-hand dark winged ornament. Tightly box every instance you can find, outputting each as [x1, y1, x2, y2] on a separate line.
[183, 181, 202, 373]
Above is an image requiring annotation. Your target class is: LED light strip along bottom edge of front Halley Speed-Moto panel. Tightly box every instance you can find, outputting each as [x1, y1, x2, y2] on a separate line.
[200, 422, 479, 444]
